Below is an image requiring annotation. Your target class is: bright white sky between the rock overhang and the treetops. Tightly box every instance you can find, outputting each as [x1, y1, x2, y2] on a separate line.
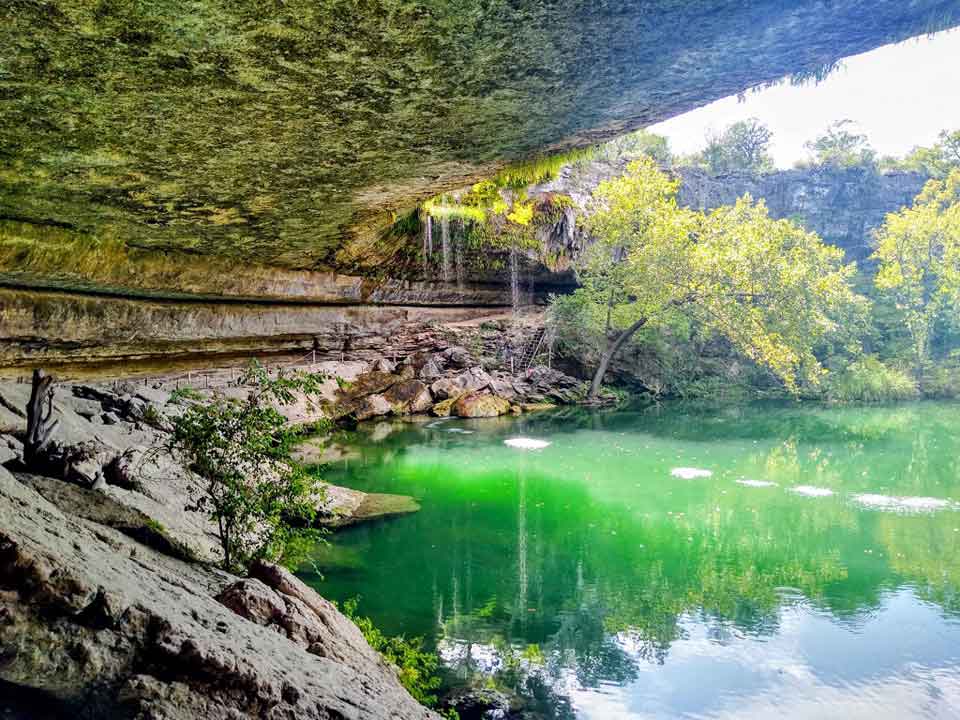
[648, 29, 960, 167]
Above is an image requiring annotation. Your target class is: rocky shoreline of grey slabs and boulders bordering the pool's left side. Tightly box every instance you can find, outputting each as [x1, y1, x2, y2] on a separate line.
[0, 330, 582, 720]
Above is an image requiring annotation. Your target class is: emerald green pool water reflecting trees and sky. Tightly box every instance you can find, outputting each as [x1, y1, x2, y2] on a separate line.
[304, 403, 960, 720]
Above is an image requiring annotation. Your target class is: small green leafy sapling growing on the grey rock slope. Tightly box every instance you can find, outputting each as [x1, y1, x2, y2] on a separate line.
[174, 364, 332, 570]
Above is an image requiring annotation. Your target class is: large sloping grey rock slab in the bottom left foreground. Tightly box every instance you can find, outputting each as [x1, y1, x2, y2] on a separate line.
[0, 468, 438, 720]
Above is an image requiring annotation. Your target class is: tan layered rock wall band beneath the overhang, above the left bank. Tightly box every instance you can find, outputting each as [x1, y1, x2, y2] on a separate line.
[0, 288, 502, 370]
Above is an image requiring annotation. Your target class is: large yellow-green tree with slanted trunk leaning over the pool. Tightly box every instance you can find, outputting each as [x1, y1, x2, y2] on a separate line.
[576, 158, 858, 399]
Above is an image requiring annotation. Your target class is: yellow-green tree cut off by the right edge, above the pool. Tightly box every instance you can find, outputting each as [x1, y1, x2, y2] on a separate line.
[873, 169, 960, 380]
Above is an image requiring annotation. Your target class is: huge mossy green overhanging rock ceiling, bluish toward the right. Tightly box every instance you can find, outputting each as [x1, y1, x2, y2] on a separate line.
[0, 0, 958, 293]
